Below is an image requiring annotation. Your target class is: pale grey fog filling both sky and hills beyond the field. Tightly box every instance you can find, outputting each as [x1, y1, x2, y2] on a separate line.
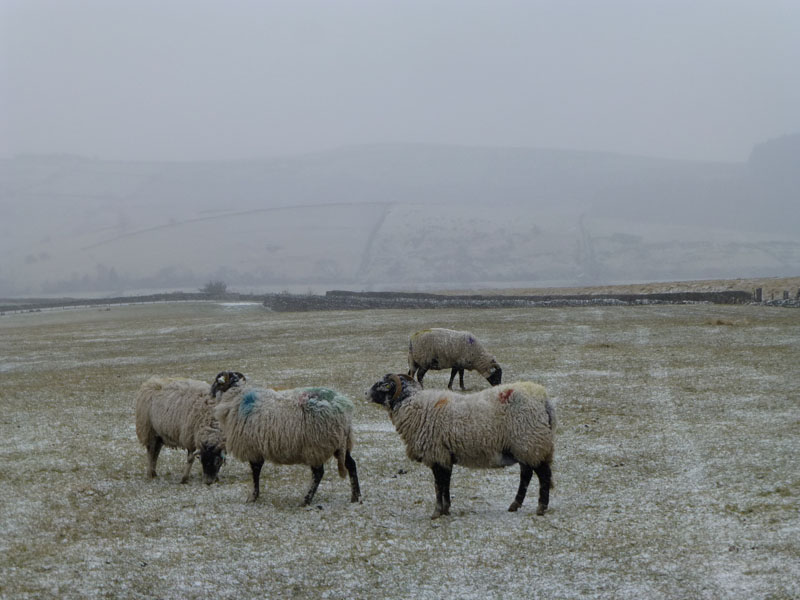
[0, 0, 800, 294]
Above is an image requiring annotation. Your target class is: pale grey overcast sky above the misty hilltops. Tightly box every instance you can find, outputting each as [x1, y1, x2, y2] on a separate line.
[0, 0, 800, 161]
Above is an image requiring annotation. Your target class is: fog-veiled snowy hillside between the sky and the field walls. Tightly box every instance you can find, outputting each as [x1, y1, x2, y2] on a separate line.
[0, 136, 800, 296]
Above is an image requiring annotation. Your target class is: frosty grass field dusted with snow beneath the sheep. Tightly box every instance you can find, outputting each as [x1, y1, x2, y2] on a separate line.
[0, 303, 800, 599]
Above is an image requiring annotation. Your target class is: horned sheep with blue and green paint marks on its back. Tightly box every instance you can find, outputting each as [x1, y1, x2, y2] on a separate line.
[211, 371, 361, 506]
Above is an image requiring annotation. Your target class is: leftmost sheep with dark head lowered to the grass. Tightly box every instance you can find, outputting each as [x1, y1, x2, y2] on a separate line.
[136, 377, 225, 484]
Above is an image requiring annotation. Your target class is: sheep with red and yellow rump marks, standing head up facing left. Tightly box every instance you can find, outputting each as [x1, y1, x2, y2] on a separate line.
[367, 373, 556, 519]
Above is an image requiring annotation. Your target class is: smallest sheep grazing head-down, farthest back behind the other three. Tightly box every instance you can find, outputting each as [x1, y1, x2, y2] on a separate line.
[408, 327, 503, 390]
